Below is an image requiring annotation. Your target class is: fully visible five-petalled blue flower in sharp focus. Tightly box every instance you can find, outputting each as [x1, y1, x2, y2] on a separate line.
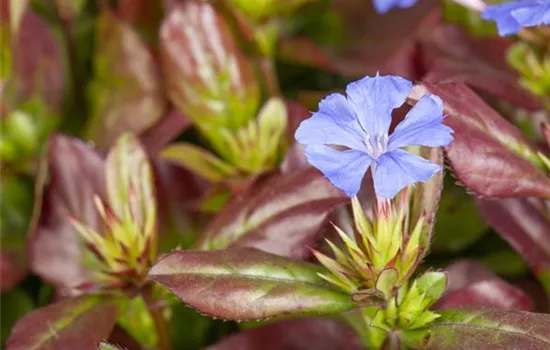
[295, 75, 453, 198]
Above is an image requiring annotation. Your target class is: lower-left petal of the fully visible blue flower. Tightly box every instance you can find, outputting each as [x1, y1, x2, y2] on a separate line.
[305, 145, 372, 197]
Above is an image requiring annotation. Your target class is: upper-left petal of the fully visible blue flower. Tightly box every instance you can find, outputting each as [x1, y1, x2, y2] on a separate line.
[294, 94, 366, 150]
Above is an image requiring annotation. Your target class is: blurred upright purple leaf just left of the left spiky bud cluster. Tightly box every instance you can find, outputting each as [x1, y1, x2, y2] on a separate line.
[27, 135, 104, 289]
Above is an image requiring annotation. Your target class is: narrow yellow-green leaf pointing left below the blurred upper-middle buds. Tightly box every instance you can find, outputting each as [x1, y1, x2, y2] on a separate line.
[161, 142, 238, 182]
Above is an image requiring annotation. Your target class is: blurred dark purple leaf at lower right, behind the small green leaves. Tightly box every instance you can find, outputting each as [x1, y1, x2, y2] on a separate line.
[435, 260, 533, 311]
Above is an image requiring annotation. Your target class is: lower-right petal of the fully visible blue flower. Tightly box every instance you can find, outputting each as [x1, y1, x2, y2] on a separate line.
[374, 149, 441, 198]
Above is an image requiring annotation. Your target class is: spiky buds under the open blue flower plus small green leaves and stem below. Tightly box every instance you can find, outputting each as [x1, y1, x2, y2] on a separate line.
[314, 187, 447, 348]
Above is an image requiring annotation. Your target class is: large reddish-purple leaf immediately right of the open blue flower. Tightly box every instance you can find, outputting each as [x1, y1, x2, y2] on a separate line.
[411, 83, 550, 198]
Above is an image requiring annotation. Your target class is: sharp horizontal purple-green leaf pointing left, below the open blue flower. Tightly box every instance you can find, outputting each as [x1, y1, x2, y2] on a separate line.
[149, 248, 354, 320]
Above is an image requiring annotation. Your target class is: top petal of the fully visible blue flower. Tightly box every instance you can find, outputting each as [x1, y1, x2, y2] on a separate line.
[346, 75, 412, 136]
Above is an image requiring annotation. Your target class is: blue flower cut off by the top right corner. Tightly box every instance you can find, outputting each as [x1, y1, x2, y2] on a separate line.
[481, 0, 550, 36]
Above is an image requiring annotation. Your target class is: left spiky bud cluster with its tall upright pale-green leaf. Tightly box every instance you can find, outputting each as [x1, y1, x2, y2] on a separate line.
[70, 134, 157, 291]
